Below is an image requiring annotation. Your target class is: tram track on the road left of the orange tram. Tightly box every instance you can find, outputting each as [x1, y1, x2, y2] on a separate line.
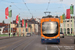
[12, 37, 37, 50]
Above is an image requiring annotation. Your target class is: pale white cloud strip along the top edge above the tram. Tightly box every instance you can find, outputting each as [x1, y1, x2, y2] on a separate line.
[25, 0, 75, 5]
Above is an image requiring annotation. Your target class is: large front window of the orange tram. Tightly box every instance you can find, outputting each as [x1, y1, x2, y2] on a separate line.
[42, 22, 58, 37]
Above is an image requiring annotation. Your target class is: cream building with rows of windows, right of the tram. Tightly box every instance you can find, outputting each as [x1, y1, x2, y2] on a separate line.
[60, 17, 75, 35]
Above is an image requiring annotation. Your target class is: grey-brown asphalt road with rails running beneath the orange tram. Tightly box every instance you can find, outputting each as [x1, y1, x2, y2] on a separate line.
[0, 35, 75, 50]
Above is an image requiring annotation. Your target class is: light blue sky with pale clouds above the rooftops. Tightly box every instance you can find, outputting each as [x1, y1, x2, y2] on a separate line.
[0, 0, 75, 23]
